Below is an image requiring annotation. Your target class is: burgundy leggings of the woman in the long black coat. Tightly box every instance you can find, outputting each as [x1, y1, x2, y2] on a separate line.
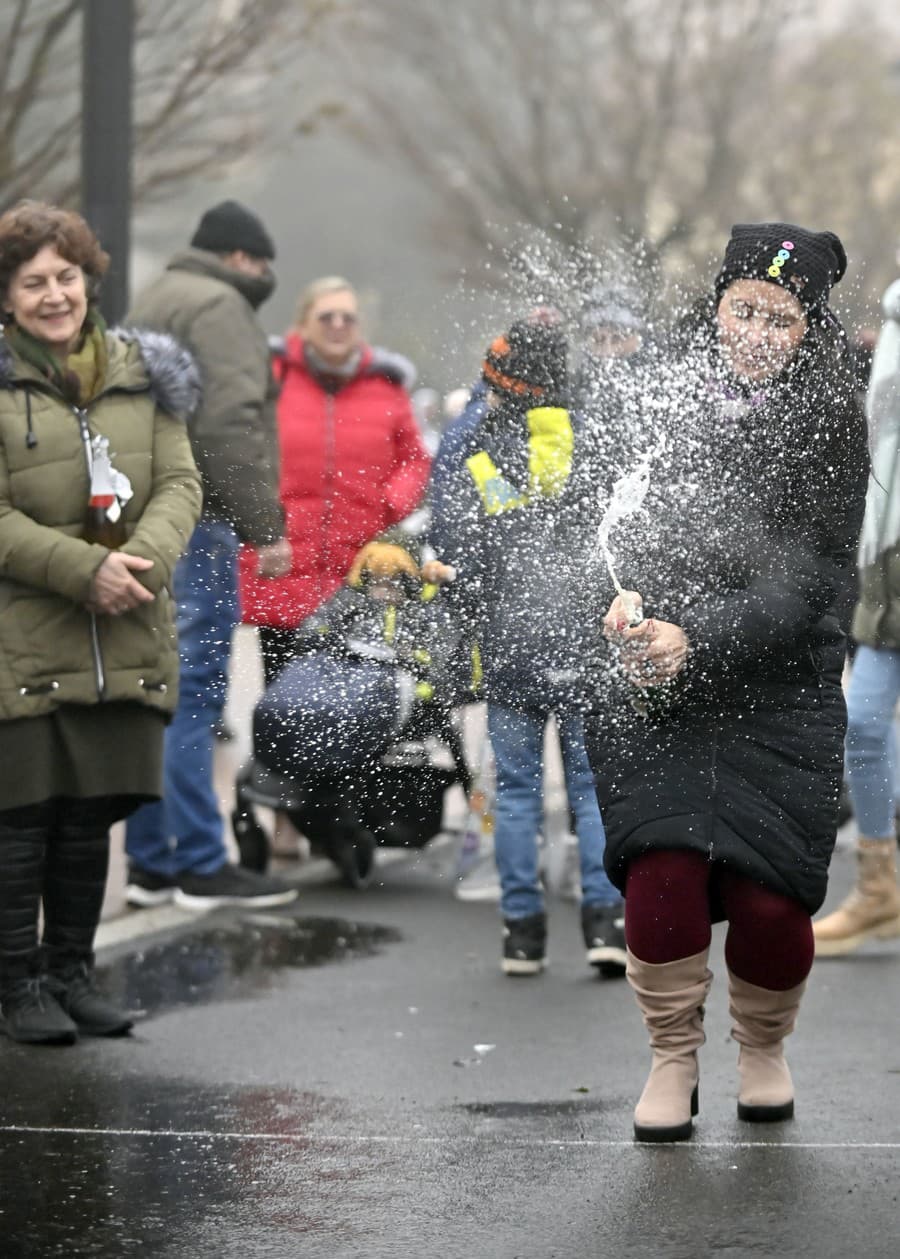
[626, 849, 813, 992]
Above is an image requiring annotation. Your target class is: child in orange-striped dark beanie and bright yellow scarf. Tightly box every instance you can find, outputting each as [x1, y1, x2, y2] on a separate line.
[430, 320, 626, 974]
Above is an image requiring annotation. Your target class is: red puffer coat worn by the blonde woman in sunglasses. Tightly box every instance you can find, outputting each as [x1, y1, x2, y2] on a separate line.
[239, 336, 430, 628]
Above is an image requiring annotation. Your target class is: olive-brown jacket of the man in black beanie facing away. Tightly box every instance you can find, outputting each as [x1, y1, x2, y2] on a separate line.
[130, 249, 284, 546]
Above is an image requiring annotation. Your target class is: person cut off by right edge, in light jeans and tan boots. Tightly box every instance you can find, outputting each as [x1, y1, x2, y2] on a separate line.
[813, 279, 900, 957]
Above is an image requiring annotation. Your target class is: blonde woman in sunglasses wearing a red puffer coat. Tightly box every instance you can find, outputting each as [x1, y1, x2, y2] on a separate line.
[240, 276, 430, 685]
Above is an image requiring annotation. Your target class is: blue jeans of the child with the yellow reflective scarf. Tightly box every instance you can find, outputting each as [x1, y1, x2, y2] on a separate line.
[487, 704, 622, 918]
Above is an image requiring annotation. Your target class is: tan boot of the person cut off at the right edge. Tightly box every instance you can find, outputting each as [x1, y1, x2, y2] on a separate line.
[813, 838, 900, 957]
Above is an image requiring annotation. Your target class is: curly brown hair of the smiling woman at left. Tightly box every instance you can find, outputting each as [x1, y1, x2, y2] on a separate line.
[0, 201, 110, 324]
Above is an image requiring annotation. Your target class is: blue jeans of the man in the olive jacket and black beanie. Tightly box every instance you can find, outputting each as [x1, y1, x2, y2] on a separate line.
[125, 520, 238, 879]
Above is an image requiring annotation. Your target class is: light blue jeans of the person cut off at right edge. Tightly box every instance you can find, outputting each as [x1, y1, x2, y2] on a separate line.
[846, 647, 900, 841]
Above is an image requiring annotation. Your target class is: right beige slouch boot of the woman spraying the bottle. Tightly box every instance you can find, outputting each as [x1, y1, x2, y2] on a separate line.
[728, 971, 806, 1123]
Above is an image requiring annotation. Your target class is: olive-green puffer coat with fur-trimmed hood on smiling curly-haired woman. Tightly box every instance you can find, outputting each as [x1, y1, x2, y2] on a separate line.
[0, 332, 201, 720]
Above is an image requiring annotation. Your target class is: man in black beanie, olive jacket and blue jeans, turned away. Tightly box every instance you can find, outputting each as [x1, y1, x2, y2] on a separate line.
[126, 201, 296, 910]
